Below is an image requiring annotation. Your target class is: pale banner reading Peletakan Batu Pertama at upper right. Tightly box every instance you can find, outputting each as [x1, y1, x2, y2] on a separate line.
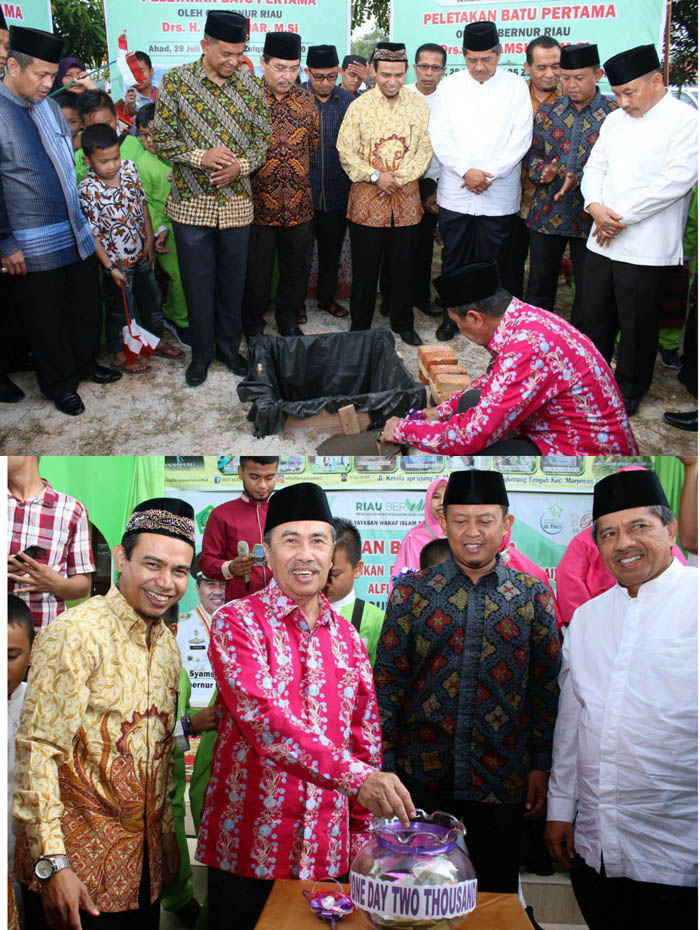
[391, 0, 666, 93]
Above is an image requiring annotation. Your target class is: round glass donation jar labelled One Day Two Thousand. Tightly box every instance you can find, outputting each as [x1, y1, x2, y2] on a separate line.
[350, 810, 476, 930]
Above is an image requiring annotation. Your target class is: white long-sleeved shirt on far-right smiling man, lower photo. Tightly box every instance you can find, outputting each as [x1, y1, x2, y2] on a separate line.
[547, 559, 698, 886]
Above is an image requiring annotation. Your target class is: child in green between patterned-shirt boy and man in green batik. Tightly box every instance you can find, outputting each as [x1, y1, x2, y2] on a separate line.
[136, 103, 190, 348]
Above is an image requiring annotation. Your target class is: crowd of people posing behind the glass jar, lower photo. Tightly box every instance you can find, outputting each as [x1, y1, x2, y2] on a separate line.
[8, 456, 697, 930]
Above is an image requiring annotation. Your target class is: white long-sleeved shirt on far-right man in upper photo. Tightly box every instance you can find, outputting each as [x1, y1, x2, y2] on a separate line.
[581, 92, 698, 265]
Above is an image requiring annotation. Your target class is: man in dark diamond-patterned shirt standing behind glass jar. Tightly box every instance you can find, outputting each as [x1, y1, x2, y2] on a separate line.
[374, 470, 559, 893]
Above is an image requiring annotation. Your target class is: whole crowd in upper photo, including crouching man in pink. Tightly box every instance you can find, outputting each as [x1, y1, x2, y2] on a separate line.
[0, 11, 697, 454]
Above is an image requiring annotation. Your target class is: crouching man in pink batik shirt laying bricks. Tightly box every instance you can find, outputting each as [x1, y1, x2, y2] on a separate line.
[382, 262, 639, 455]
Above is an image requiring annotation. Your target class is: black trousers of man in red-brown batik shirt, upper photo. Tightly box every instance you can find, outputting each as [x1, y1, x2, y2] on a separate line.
[243, 220, 314, 336]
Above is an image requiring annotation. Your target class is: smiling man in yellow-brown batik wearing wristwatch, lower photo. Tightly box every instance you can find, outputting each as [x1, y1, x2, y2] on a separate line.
[12, 498, 194, 930]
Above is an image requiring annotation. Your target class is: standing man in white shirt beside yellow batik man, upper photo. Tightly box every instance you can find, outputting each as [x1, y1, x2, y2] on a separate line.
[430, 21, 532, 341]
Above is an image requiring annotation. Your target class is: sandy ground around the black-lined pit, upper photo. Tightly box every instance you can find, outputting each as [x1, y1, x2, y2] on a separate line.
[0, 266, 697, 455]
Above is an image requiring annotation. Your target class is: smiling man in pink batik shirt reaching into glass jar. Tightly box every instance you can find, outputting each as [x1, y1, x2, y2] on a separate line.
[197, 483, 414, 930]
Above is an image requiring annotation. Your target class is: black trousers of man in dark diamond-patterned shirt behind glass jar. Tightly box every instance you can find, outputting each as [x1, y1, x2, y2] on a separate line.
[397, 771, 525, 894]
